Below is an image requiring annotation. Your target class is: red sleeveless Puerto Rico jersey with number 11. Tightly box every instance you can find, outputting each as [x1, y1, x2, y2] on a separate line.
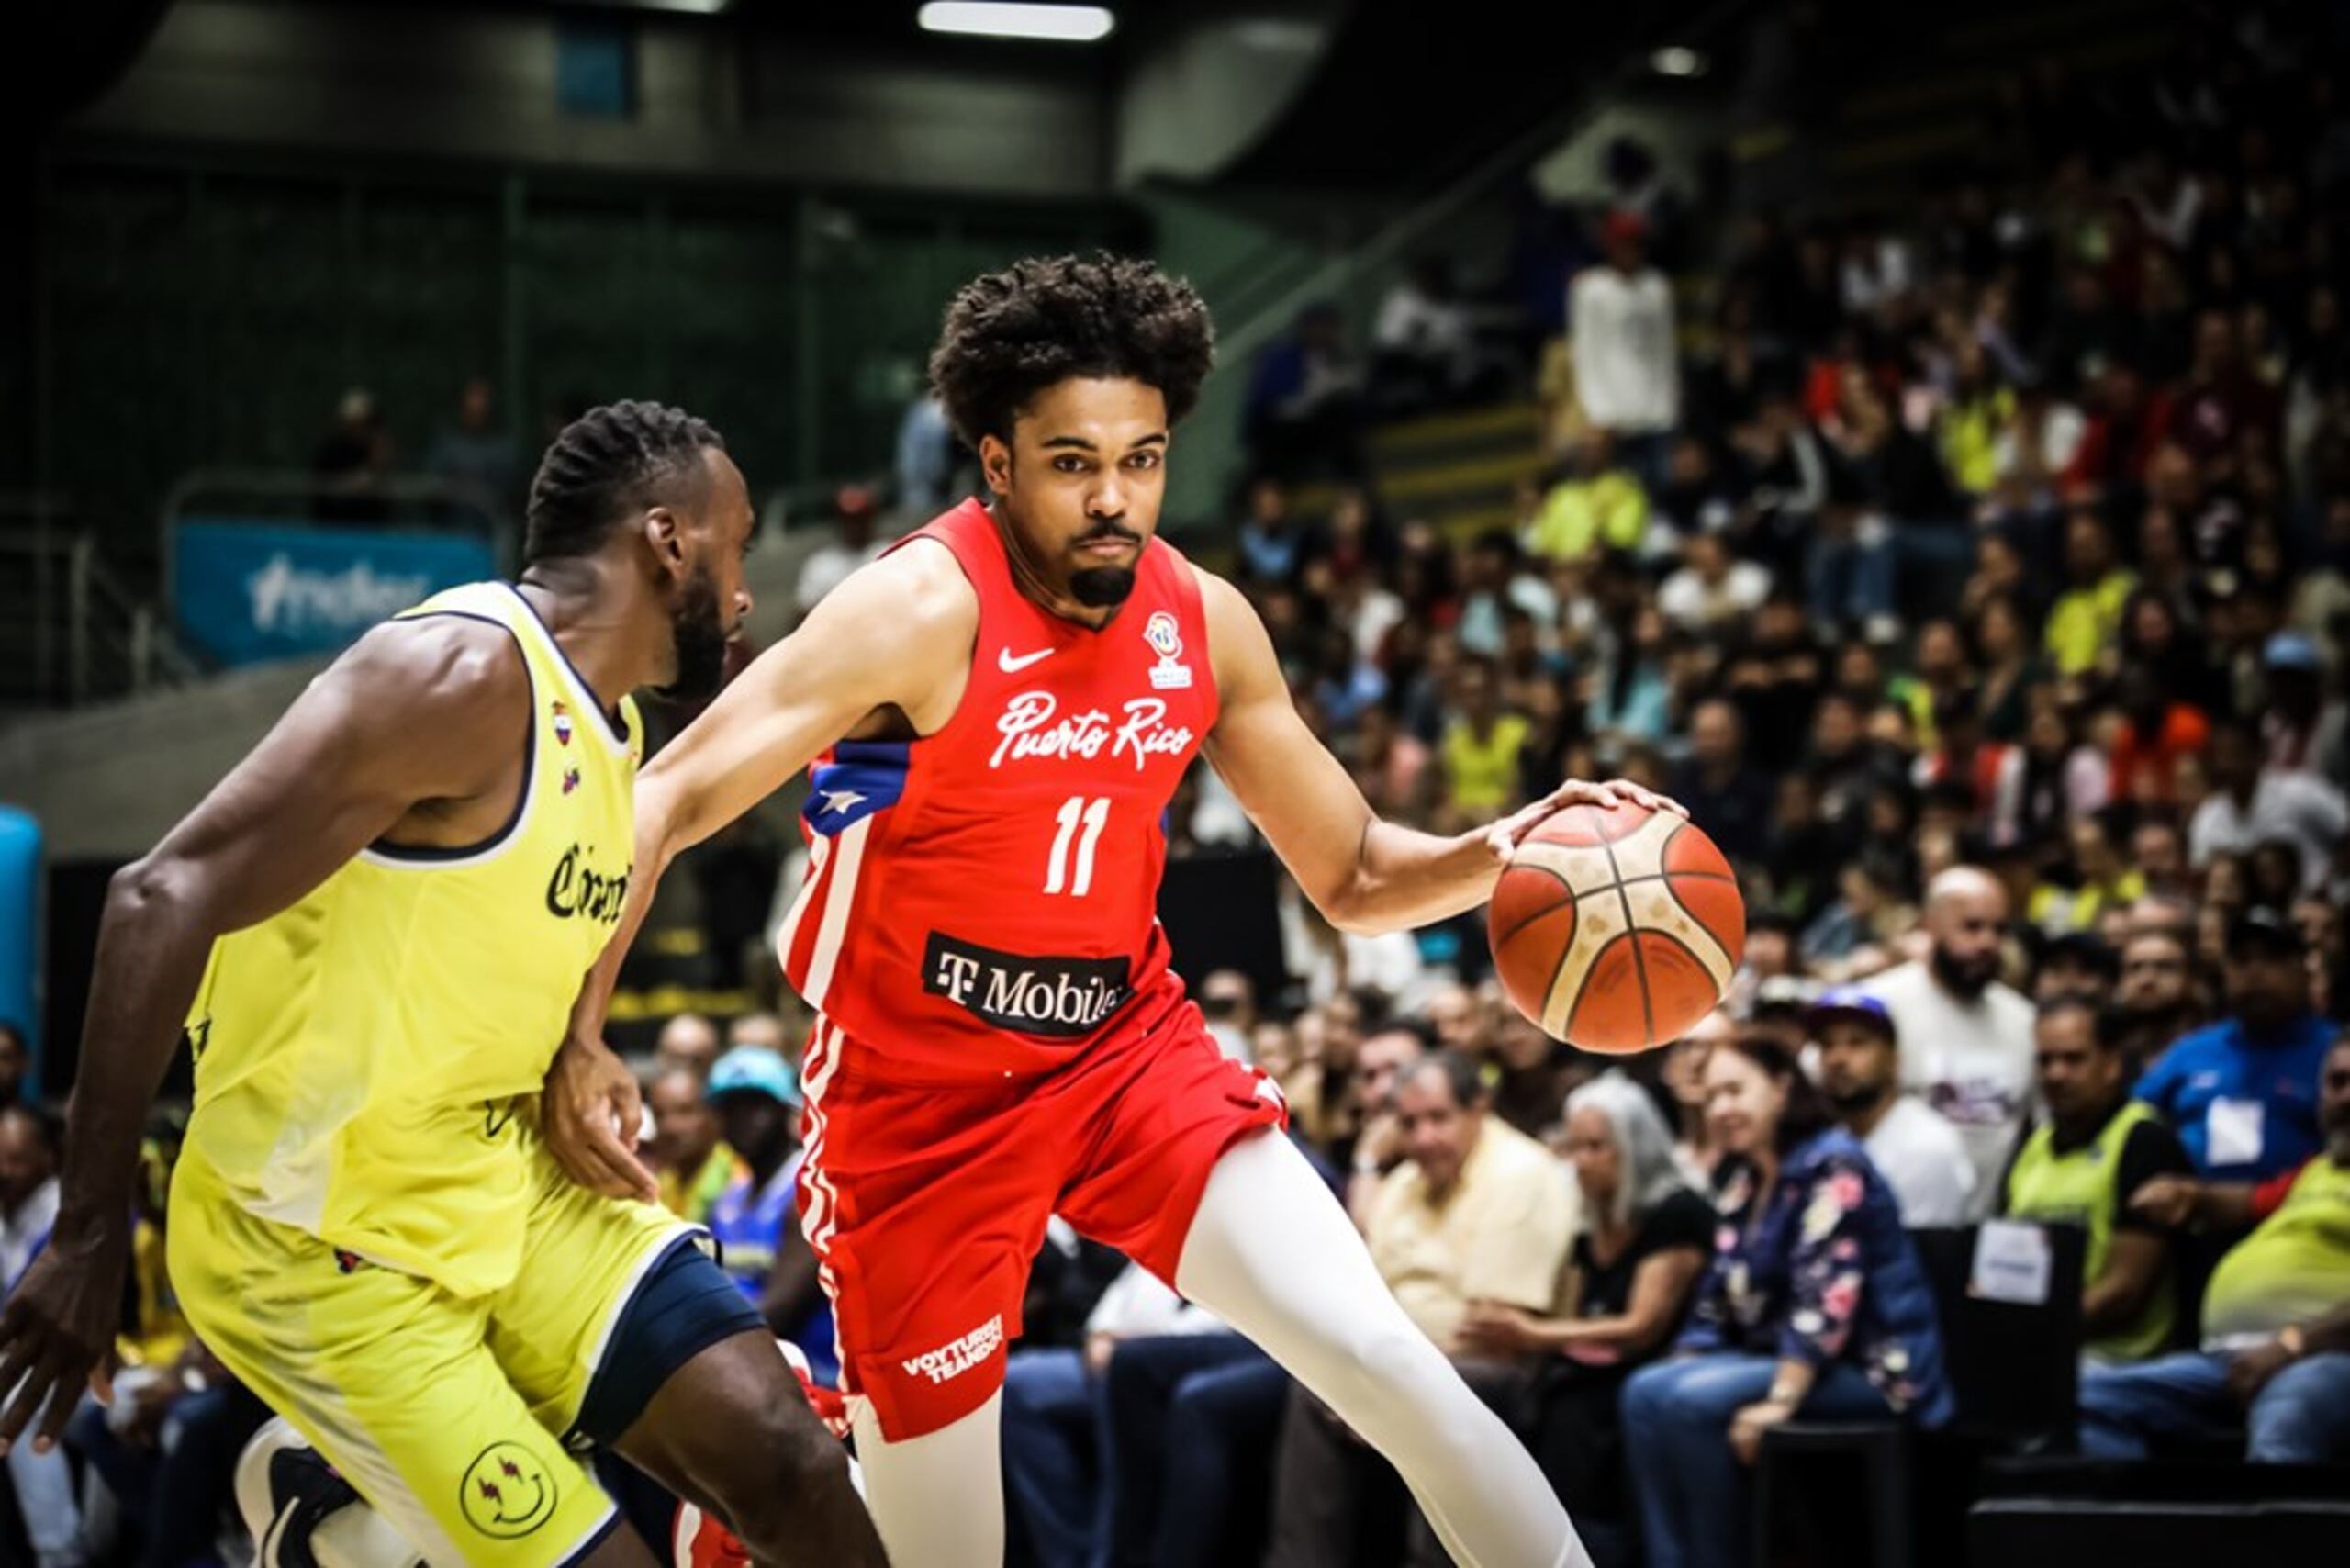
[778, 500, 1217, 1081]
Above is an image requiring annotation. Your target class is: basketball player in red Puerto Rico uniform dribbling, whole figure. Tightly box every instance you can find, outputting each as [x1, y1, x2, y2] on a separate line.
[545, 259, 1659, 1568]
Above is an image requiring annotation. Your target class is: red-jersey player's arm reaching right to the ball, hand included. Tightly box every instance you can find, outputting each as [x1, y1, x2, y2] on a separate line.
[1196, 571, 1678, 935]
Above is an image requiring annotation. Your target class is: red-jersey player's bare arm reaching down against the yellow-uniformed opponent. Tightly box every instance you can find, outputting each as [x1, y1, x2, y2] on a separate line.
[541, 545, 980, 1202]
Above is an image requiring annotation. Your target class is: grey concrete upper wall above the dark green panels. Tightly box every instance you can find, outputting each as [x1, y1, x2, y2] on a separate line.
[71, 0, 1109, 196]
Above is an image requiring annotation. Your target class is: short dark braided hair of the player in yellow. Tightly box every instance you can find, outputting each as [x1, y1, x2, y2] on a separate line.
[521, 402, 726, 565]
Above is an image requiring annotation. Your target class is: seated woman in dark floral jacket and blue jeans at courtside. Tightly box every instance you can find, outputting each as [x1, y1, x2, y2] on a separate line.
[1624, 1035, 1951, 1568]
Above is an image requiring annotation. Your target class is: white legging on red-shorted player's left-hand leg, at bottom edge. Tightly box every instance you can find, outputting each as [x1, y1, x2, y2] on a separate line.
[851, 1389, 1003, 1568]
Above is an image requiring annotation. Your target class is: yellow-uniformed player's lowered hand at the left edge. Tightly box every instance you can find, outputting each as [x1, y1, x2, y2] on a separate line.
[0, 1229, 129, 1453]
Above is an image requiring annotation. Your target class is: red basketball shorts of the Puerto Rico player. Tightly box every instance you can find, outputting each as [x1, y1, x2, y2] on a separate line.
[799, 1006, 1288, 1441]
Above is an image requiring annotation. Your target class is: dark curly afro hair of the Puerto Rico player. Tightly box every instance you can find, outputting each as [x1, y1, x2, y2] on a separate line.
[931, 254, 1215, 449]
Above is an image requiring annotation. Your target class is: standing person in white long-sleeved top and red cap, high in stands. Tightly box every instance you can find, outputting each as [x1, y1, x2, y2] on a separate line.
[1568, 211, 1680, 489]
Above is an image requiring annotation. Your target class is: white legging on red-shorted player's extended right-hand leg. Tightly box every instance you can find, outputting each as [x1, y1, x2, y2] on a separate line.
[1175, 1136, 1591, 1568]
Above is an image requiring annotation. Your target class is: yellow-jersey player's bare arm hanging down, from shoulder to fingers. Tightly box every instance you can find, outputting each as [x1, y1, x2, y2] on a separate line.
[0, 618, 532, 1450]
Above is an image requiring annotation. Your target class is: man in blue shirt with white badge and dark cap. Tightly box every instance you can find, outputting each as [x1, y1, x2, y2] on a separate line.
[2136, 907, 2336, 1182]
